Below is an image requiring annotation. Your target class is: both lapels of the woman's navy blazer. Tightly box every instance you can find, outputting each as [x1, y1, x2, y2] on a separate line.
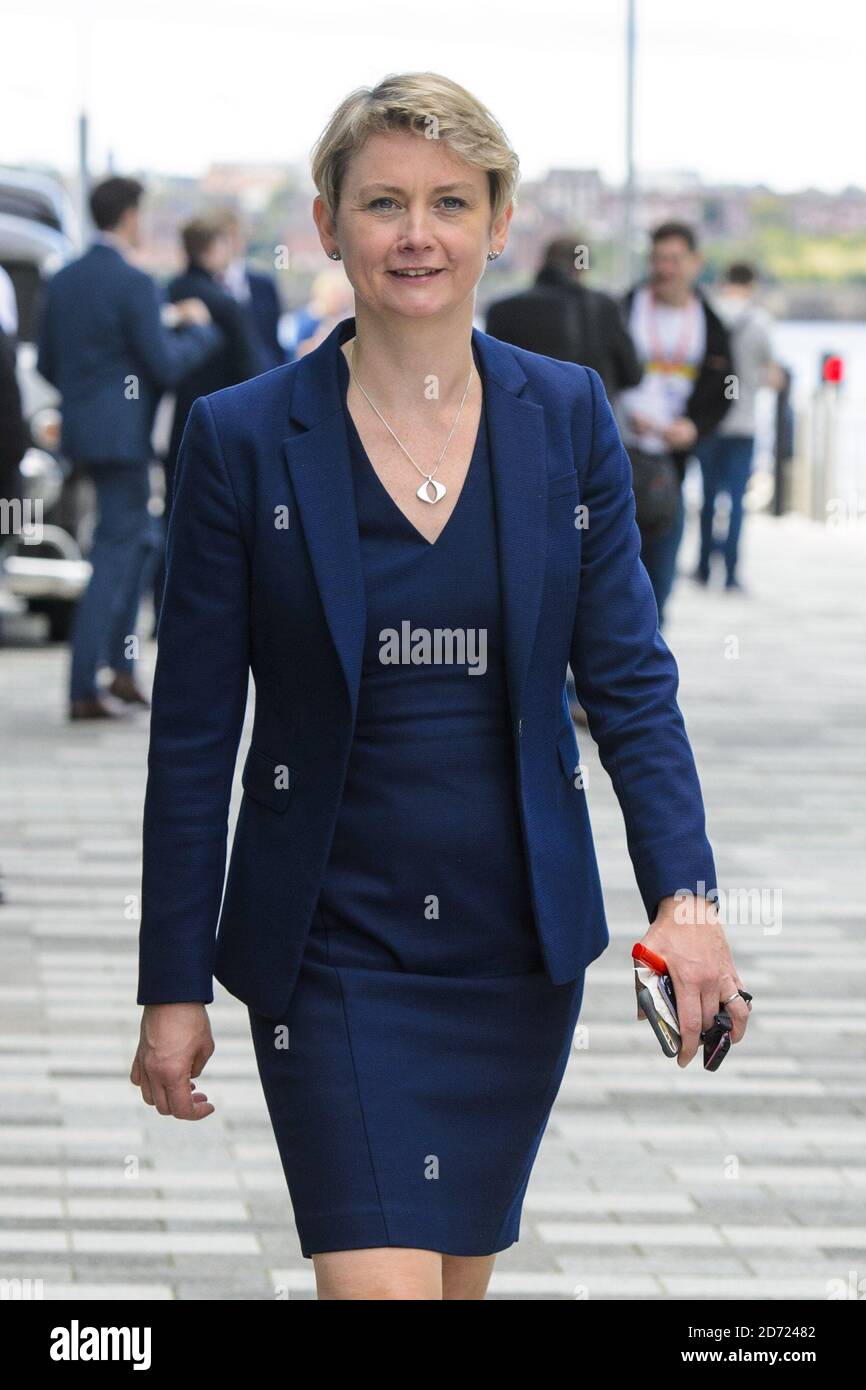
[284, 317, 548, 723]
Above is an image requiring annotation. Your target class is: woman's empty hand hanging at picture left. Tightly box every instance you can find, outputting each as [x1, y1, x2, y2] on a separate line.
[129, 1004, 214, 1120]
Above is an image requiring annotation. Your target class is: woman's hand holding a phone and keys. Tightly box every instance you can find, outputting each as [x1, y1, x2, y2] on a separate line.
[642, 895, 751, 1066]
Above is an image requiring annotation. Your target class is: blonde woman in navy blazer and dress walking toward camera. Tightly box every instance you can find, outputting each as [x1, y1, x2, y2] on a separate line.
[132, 74, 748, 1300]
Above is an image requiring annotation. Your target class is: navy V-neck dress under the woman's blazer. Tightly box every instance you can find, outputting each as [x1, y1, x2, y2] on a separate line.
[250, 339, 584, 1258]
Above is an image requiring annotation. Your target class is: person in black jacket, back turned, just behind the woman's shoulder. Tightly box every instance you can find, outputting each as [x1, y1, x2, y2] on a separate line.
[485, 235, 642, 398]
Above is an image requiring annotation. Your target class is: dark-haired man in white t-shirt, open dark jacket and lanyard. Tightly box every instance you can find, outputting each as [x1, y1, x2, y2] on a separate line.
[614, 221, 734, 627]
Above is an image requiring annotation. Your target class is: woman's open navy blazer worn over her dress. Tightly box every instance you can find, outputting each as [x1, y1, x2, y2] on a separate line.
[138, 318, 716, 1017]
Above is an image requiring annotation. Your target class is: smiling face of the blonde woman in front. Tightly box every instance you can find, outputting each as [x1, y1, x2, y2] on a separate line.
[314, 131, 512, 318]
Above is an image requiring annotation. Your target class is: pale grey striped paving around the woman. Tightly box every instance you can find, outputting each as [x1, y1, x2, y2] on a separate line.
[0, 517, 866, 1300]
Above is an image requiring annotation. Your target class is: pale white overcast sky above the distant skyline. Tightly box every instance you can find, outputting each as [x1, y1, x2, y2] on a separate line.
[0, 0, 866, 192]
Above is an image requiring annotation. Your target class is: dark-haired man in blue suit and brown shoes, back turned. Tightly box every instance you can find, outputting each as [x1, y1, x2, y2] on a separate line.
[38, 178, 222, 719]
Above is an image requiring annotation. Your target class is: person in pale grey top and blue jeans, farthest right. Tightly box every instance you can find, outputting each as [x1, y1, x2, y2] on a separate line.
[695, 261, 774, 589]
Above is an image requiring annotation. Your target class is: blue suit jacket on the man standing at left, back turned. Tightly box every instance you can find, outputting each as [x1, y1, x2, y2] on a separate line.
[36, 242, 225, 464]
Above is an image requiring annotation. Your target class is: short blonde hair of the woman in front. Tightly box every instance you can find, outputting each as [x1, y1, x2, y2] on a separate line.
[310, 72, 520, 221]
